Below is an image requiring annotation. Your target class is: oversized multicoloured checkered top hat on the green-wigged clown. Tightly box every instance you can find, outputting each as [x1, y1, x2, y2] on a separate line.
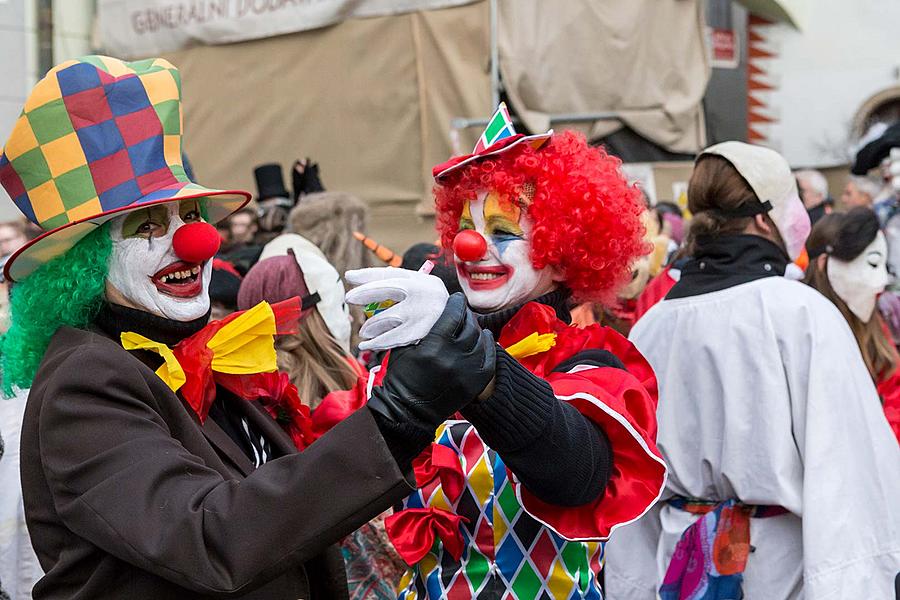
[0, 56, 250, 281]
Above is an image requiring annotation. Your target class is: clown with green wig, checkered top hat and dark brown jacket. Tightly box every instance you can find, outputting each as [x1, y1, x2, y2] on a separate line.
[0, 56, 448, 600]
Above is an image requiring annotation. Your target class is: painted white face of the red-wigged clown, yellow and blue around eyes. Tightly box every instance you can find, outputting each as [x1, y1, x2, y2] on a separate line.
[456, 192, 556, 312]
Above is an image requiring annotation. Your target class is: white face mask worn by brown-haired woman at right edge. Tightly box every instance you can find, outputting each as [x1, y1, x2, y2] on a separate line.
[828, 231, 890, 323]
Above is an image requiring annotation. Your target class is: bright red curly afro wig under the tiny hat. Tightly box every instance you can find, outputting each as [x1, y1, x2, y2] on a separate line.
[434, 131, 650, 302]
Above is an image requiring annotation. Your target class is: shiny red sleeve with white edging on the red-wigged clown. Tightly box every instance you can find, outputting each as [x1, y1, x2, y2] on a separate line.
[499, 303, 666, 540]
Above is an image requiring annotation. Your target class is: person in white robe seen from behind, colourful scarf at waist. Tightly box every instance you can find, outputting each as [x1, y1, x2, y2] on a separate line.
[606, 142, 900, 600]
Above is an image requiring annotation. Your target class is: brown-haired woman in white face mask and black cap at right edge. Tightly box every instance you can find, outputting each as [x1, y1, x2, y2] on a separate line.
[803, 207, 900, 441]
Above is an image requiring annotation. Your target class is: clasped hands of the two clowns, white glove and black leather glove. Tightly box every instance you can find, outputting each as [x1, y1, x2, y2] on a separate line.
[345, 267, 496, 430]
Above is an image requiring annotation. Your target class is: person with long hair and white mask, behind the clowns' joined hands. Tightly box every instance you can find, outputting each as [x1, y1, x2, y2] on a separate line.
[238, 239, 403, 600]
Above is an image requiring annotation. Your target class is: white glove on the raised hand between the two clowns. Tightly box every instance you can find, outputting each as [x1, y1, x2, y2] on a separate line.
[344, 267, 450, 350]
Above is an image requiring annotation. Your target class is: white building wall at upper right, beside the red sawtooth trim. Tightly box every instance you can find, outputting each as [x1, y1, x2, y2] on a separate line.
[758, 0, 900, 167]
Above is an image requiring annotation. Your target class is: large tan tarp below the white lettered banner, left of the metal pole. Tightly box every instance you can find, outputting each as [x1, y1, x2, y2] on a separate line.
[166, 2, 490, 250]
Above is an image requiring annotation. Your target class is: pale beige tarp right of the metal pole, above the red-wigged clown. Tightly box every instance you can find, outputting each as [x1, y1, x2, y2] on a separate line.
[500, 0, 709, 152]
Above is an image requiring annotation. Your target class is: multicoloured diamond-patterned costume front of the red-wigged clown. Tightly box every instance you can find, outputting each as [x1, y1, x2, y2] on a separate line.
[398, 421, 604, 600]
